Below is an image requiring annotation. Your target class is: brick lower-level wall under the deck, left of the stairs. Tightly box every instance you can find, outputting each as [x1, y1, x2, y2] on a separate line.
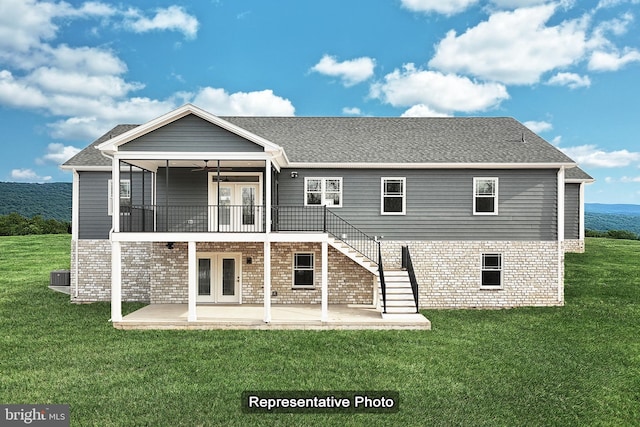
[71, 240, 374, 304]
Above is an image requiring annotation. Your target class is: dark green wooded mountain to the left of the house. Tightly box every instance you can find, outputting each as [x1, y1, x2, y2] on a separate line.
[0, 182, 72, 222]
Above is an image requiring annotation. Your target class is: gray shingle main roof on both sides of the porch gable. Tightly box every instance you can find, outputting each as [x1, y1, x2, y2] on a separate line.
[65, 117, 573, 166]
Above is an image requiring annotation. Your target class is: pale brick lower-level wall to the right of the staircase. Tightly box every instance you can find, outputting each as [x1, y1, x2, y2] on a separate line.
[383, 241, 564, 309]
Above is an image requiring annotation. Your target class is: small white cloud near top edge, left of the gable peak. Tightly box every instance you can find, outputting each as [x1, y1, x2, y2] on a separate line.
[126, 6, 200, 39]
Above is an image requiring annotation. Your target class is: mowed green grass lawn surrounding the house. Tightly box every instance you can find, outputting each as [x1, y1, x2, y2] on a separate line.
[0, 236, 640, 427]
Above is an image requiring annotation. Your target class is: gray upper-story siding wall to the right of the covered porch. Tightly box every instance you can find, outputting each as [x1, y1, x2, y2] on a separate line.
[279, 169, 557, 241]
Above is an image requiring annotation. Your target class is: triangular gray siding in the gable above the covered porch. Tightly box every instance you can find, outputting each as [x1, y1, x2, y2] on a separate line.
[120, 115, 264, 152]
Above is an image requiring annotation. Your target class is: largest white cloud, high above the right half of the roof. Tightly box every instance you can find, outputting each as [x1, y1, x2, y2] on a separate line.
[429, 3, 587, 84]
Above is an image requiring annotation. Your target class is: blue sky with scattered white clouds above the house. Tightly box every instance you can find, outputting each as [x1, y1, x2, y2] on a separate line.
[0, 0, 640, 204]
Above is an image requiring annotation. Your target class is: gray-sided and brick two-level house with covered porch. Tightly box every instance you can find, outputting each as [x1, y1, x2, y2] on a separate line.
[63, 104, 593, 322]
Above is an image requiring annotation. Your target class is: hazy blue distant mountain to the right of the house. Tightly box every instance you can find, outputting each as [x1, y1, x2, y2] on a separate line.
[584, 203, 640, 235]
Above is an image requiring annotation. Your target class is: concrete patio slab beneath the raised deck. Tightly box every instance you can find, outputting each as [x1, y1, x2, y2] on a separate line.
[113, 304, 431, 330]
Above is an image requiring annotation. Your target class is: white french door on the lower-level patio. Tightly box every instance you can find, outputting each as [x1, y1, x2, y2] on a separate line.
[196, 253, 241, 303]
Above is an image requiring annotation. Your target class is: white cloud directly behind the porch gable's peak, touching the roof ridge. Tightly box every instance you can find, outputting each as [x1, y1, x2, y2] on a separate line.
[193, 87, 295, 116]
